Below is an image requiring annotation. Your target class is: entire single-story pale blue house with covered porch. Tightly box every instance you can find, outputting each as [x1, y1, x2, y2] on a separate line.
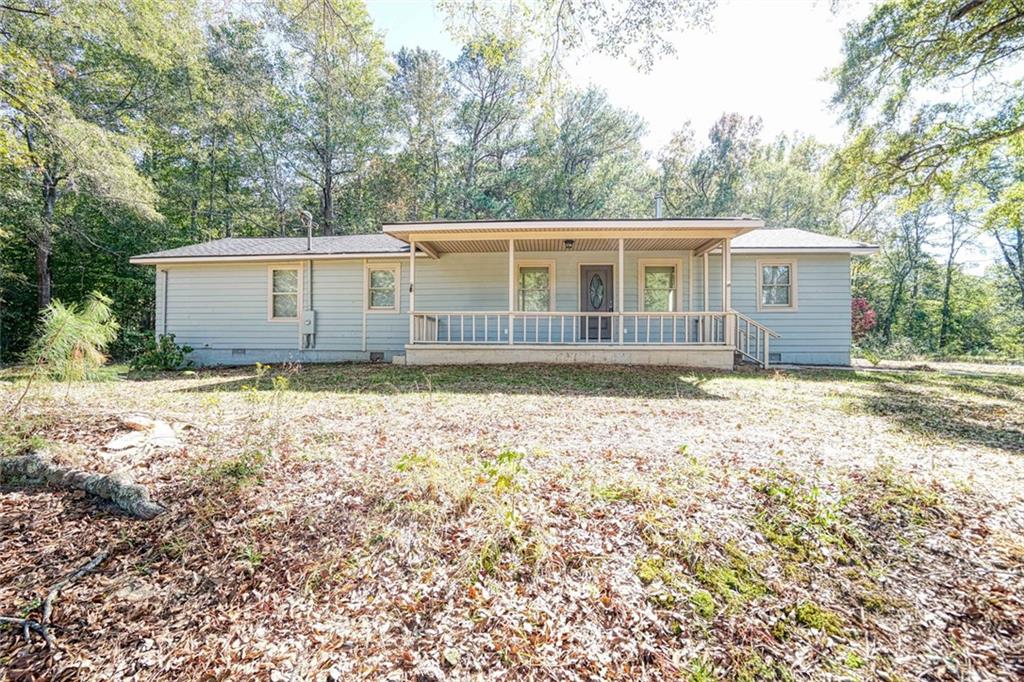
[131, 218, 877, 369]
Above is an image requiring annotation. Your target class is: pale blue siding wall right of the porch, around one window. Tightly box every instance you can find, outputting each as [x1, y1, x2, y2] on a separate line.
[732, 254, 851, 365]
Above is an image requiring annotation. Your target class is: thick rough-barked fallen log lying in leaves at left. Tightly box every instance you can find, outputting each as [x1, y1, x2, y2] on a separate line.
[0, 453, 166, 519]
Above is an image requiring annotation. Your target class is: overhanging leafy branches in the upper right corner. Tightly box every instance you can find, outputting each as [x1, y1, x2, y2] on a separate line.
[833, 0, 1024, 201]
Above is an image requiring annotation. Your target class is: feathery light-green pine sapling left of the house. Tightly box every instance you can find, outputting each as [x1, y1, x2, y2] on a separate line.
[26, 292, 118, 381]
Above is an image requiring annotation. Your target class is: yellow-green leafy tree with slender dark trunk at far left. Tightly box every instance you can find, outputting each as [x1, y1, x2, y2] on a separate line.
[0, 0, 196, 308]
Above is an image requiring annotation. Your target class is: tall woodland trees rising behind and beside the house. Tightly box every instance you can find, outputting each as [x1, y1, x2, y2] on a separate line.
[0, 0, 1024, 366]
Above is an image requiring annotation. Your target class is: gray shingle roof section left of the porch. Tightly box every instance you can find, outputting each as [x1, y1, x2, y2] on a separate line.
[135, 232, 409, 258]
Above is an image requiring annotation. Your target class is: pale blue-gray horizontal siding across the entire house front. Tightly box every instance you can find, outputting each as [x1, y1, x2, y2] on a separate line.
[156, 251, 850, 365]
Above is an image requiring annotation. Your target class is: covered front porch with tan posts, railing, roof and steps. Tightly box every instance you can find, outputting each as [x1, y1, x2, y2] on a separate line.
[385, 218, 774, 369]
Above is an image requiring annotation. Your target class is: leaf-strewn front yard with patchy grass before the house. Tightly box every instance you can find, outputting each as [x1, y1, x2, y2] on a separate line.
[0, 366, 1024, 680]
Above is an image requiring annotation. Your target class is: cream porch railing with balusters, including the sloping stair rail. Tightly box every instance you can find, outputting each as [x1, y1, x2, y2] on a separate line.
[411, 310, 778, 367]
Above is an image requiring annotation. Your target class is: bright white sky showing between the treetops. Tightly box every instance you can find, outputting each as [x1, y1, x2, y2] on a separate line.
[368, 0, 869, 152]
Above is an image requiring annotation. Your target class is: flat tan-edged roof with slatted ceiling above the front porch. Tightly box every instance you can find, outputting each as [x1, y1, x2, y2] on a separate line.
[383, 217, 764, 254]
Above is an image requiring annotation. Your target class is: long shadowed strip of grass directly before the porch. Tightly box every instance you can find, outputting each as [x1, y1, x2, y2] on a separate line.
[182, 365, 725, 400]
